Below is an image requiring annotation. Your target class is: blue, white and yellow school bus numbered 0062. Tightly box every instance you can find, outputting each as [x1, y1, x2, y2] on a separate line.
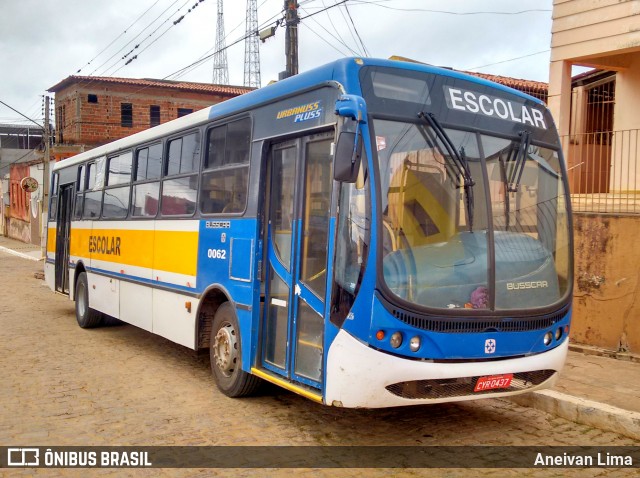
[45, 58, 573, 407]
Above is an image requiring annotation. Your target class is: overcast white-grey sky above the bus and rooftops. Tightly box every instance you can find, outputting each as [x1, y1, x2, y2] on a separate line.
[0, 0, 552, 124]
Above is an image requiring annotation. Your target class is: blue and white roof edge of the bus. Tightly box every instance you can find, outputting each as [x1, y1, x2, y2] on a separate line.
[54, 57, 544, 170]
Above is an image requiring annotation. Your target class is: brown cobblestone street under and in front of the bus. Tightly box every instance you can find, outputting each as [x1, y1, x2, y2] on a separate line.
[0, 253, 638, 477]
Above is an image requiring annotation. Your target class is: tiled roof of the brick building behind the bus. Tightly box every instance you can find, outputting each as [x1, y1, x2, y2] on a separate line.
[48, 75, 255, 96]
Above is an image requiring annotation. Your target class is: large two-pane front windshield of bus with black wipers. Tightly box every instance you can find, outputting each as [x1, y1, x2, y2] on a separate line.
[373, 119, 571, 310]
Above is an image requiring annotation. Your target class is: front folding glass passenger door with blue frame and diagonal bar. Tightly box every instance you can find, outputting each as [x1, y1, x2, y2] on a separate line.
[261, 134, 333, 389]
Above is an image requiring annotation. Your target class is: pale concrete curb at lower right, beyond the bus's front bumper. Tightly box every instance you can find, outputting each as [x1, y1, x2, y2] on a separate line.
[508, 390, 640, 440]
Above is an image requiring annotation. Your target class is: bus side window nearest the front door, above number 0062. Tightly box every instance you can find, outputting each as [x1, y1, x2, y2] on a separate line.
[200, 118, 251, 214]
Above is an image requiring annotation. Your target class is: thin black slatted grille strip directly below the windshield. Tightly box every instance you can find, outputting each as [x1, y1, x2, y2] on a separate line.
[393, 309, 567, 334]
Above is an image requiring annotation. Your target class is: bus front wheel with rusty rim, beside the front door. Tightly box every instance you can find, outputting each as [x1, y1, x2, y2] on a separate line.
[209, 302, 262, 397]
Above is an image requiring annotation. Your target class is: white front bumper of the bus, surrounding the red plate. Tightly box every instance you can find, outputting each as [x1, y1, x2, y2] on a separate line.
[324, 330, 569, 408]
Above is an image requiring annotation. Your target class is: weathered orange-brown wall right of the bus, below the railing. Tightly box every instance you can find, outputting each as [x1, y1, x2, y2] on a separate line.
[570, 214, 640, 353]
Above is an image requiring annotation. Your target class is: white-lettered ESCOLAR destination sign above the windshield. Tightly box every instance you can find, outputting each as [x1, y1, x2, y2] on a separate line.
[445, 87, 547, 129]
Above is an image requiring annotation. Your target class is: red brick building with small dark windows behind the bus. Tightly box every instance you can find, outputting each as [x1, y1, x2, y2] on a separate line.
[49, 76, 253, 160]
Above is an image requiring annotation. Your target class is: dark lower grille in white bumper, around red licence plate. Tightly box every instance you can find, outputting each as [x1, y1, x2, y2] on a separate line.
[386, 370, 556, 400]
